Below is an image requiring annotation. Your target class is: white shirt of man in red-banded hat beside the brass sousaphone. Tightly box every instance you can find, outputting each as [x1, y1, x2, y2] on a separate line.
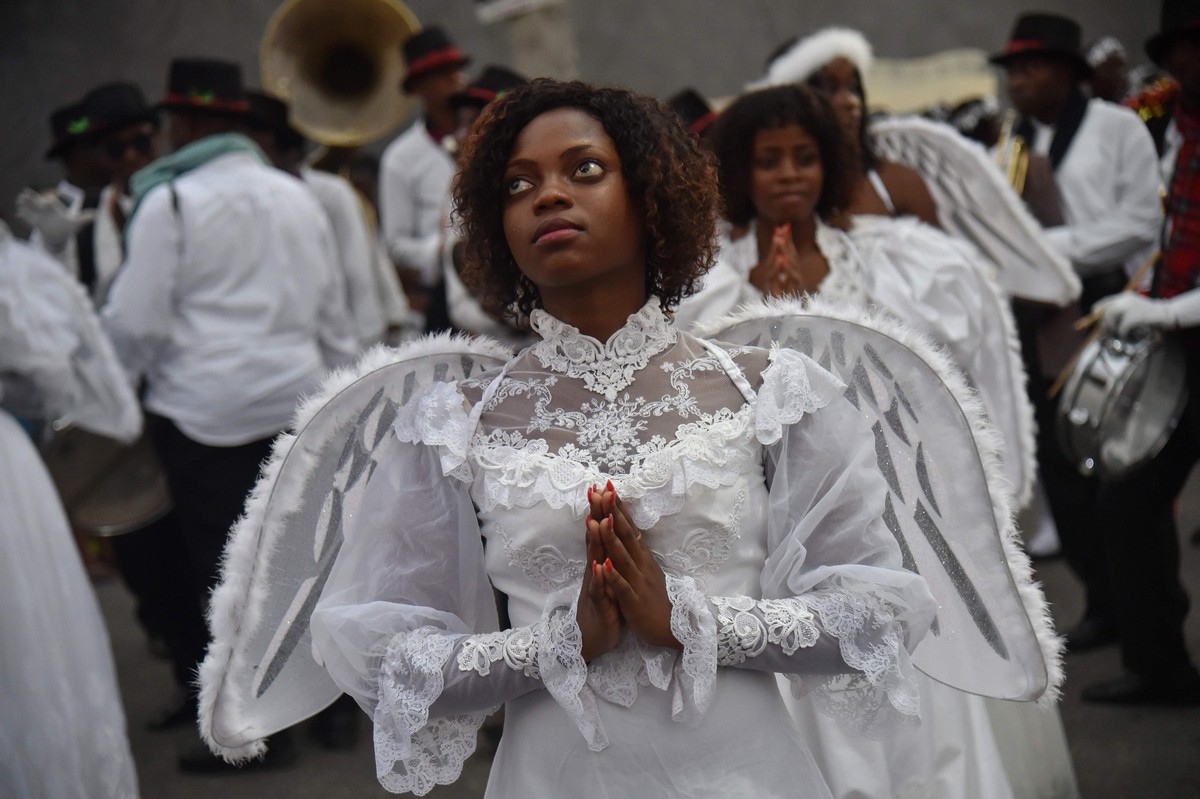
[379, 118, 455, 286]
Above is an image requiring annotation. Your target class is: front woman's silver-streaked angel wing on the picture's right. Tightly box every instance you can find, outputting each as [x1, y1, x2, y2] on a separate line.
[704, 300, 1062, 701]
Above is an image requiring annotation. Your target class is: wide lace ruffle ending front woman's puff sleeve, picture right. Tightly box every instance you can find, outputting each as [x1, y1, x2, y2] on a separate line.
[788, 590, 920, 738]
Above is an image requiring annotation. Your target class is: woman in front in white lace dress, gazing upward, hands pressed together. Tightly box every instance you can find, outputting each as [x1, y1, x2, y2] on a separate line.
[312, 80, 932, 798]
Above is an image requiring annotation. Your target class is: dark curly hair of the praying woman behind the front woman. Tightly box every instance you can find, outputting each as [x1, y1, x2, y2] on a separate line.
[713, 85, 858, 226]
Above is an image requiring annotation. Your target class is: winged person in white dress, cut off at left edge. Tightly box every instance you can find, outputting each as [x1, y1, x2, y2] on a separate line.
[0, 222, 142, 799]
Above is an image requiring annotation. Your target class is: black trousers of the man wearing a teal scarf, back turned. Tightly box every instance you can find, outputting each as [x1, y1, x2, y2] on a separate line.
[146, 414, 274, 668]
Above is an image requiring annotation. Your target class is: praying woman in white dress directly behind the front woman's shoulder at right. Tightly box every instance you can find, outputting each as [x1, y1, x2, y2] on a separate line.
[679, 85, 1078, 799]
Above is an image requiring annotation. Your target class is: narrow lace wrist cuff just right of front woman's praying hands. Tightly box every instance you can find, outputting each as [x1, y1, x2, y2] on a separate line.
[665, 573, 716, 721]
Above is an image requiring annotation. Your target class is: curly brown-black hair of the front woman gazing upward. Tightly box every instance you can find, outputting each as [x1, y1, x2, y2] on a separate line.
[454, 79, 719, 318]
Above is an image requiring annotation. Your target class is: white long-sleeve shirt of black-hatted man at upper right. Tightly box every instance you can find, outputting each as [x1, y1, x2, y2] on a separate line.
[1033, 98, 1163, 277]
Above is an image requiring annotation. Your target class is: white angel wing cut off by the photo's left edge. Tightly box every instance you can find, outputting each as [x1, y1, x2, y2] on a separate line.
[0, 223, 142, 443]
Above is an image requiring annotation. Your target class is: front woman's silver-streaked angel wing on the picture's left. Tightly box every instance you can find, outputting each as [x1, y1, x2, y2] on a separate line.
[199, 335, 511, 761]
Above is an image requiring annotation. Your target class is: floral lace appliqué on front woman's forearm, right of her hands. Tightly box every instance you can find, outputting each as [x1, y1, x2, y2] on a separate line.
[712, 596, 821, 666]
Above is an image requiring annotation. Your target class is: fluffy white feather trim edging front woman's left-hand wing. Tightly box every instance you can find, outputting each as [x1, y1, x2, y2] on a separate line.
[198, 334, 512, 763]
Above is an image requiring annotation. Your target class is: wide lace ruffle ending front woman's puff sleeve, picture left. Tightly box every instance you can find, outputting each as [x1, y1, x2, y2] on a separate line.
[373, 627, 488, 795]
